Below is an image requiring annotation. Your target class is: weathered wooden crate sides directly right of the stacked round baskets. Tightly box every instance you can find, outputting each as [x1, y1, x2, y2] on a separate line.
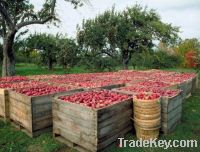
[161, 92, 183, 134]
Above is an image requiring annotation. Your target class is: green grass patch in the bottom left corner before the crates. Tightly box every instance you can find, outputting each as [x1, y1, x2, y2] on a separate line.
[0, 121, 64, 152]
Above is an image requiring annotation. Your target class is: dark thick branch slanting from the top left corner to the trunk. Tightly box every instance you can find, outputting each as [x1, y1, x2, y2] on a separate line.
[0, 0, 14, 28]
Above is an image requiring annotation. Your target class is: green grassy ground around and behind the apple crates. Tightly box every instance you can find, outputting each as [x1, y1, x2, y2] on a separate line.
[0, 64, 200, 152]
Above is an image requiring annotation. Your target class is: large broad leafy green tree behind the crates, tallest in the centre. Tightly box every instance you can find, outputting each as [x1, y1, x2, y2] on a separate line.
[77, 5, 179, 68]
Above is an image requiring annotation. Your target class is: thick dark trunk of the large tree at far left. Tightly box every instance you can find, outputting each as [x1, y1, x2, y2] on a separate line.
[2, 32, 15, 77]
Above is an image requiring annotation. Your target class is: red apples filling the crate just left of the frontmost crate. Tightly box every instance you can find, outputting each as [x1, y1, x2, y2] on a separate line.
[15, 85, 71, 96]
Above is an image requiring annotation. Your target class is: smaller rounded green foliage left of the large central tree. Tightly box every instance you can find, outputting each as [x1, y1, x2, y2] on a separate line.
[23, 34, 80, 70]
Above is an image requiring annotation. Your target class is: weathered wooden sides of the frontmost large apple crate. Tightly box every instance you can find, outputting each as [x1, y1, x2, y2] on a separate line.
[53, 95, 133, 152]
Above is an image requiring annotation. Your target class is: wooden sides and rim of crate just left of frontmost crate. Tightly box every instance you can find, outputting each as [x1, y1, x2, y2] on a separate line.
[9, 89, 81, 137]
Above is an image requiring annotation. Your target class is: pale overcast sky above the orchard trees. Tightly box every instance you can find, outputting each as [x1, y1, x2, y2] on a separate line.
[25, 0, 200, 39]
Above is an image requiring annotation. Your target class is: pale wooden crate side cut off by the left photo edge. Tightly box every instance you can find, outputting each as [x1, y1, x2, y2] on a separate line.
[0, 89, 9, 121]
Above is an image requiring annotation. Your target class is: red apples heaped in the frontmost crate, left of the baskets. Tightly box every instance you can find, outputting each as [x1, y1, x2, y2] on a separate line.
[59, 90, 130, 109]
